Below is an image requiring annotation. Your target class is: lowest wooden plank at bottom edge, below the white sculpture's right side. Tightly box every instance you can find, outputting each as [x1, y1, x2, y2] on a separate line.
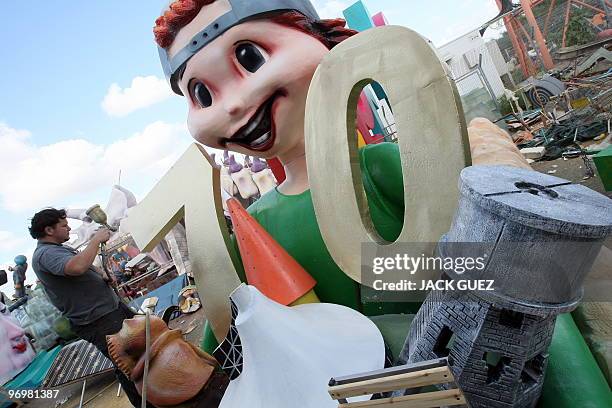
[338, 390, 465, 408]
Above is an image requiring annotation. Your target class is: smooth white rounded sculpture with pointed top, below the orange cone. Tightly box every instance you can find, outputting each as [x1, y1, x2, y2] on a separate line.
[219, 285, 385, 408]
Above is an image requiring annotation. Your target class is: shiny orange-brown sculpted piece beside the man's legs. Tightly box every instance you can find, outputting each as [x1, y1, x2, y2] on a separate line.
[106, 316, 218, 406]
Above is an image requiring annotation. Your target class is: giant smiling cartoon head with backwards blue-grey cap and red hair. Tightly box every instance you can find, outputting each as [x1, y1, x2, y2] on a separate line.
[154, 0, 355, 163]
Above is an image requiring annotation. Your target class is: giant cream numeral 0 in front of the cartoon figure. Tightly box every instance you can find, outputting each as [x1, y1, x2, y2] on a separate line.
[306, 26, 470, 282]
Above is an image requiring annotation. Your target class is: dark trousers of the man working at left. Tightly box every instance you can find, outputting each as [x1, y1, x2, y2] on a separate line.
[71, 302, 148, 407]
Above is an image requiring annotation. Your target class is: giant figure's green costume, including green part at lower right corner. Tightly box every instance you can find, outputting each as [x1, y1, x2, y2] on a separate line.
[202, 143, 612, 407]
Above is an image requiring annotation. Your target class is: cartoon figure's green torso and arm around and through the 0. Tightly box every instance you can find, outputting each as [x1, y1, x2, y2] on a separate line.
[202, 143, 418, 355]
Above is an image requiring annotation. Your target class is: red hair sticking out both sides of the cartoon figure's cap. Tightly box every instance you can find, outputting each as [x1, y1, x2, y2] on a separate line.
[153, 0, 357, 49]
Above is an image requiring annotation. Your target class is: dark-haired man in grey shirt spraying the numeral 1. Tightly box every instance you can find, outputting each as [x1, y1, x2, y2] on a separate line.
[29, 208, 146, 407]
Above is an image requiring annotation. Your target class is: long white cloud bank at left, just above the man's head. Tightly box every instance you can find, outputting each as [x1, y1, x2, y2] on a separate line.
[0, 122, 191, 212]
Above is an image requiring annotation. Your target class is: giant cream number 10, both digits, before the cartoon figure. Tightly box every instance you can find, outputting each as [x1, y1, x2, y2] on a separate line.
[123, 26, 470, 339]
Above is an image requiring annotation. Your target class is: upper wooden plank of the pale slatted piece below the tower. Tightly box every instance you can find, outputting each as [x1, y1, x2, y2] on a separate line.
[328, 366, 454, 400]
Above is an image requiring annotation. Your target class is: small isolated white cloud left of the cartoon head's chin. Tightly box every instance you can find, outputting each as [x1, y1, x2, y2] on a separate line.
[102, 75, 172, 117]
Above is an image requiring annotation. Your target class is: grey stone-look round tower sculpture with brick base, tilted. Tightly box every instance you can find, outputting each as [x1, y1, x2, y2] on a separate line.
[401, 166, 612, 408]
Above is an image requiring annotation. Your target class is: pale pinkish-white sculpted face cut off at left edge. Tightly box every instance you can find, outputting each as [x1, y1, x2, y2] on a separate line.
[0, 303, 35, 384]
